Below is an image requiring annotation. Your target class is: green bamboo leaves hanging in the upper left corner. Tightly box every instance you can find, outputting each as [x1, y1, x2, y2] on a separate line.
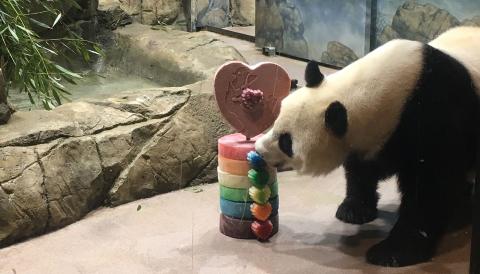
[0, 0, 100, 109]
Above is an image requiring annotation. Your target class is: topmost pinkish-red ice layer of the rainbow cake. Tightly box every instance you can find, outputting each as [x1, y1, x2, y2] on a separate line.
[218, 133, 262, 161]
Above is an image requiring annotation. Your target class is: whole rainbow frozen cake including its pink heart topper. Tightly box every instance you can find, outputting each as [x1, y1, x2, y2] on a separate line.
[215, 62, 290, 240]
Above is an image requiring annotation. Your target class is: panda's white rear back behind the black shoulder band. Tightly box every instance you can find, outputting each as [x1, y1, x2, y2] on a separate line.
[429, 27, 480, 93]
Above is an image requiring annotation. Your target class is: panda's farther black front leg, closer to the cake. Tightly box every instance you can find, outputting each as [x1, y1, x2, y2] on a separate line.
[335, 154, 385, 224]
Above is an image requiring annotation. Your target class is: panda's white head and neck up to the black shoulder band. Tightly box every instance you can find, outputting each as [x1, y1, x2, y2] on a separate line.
[256, 40, 423, 175]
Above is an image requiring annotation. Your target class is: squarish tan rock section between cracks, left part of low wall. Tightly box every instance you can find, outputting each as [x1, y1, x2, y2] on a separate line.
[40, 137, 105, 229]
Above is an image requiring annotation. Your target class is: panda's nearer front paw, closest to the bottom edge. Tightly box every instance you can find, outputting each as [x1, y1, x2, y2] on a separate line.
[366, 234, 432, 267]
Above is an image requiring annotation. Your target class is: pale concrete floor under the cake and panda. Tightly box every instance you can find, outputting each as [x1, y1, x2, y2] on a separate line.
[0, 170, 470, 274]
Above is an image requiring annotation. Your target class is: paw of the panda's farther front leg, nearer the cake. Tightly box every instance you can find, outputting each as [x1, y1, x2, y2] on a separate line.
[335, 197, 377, 225]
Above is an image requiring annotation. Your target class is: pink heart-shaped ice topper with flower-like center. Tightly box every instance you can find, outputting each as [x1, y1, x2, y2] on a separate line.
[215, 61, 290, 138]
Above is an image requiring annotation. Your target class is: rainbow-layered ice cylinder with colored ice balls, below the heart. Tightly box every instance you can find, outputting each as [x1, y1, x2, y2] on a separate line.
[218, 133, 278, 240]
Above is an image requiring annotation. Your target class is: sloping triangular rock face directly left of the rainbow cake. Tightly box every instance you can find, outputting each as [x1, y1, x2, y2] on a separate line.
[109, 84, 230, 205]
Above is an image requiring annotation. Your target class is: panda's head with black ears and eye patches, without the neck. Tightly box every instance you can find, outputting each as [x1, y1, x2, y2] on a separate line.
[256, 61, 349, 175]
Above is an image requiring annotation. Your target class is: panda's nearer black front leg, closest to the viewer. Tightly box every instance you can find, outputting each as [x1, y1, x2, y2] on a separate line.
[367, 170, 451, 267]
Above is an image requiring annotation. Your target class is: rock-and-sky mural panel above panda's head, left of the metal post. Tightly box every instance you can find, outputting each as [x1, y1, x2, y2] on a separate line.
[255, 0, 369, 66]
